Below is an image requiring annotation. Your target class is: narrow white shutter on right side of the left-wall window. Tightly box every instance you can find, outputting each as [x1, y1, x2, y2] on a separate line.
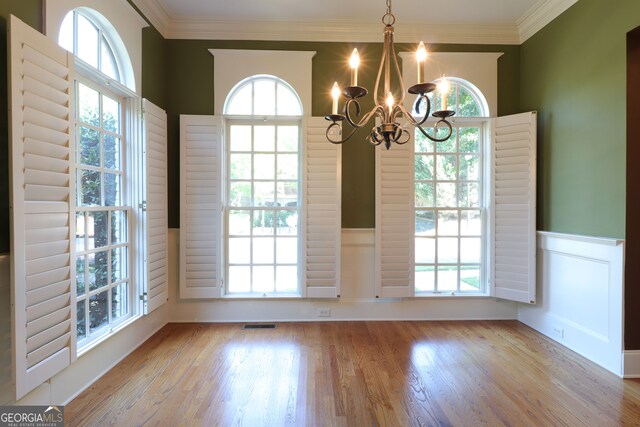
[142, 99, 169, 314]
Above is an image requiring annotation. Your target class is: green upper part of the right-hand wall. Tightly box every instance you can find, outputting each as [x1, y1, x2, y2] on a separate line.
[520, 0, 640, 237]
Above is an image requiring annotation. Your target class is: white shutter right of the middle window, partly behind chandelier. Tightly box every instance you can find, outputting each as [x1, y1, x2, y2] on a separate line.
[303, 117, 342, 298]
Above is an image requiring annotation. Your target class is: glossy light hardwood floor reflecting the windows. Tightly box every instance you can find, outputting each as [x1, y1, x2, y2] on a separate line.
[65, 321, 640, 426]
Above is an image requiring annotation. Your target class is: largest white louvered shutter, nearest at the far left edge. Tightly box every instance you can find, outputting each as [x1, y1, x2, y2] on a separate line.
[9, 16, 76, 400]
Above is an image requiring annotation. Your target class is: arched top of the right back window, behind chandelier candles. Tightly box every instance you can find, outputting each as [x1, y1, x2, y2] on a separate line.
[431, 76, 490, 117]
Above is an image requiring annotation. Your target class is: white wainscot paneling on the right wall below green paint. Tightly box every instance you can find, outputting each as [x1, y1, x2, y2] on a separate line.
[518, 232, 624, 376]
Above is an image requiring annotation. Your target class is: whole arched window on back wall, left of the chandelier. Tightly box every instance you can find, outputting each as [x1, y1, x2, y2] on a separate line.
[225, 76, 302, 295]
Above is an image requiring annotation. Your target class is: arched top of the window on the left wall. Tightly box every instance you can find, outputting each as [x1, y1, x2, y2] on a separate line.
[58, 8, 135, 89]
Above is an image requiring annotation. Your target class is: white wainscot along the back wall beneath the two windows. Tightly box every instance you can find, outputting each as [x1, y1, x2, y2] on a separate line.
[169, 229, 517, 322]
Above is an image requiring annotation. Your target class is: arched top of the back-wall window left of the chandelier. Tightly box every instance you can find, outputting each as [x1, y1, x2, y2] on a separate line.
[224, 75, 302, 116]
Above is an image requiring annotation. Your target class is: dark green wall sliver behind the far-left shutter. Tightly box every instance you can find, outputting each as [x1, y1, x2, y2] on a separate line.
[0, 0, 42, 254]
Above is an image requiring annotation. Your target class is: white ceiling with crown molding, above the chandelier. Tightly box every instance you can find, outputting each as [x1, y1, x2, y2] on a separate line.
[133, 0, 578, 44]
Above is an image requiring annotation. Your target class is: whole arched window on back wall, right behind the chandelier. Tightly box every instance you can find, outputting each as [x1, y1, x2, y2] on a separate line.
[414, 79, 488, 294]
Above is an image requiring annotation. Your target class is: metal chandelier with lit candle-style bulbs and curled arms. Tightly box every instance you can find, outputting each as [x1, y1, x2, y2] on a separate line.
[325, 0, 455, 150]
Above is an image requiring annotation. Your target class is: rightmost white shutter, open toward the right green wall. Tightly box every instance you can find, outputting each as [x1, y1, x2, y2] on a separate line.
[491, 112, 537, 304]
